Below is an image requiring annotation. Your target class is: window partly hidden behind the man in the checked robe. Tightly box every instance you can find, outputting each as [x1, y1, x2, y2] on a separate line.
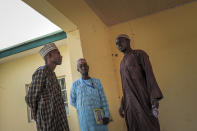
[25, 77, 69, 122]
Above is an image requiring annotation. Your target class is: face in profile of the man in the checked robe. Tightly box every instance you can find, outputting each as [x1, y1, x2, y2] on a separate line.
[50, 49, 62, 65]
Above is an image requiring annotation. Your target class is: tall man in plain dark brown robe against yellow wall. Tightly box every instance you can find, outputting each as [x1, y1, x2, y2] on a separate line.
[116, 34, 163, 131]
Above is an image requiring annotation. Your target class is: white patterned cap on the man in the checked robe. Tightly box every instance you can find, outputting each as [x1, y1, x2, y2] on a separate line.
[40, 43, 57, 58]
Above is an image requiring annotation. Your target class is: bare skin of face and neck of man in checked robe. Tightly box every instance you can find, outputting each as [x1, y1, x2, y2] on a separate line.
[45, 49, 62, 71]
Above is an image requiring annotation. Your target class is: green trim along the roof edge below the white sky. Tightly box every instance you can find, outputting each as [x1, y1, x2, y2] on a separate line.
[0, 31, 67, 59]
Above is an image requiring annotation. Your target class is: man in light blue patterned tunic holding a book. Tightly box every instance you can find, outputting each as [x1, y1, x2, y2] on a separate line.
[70, 58, 110, 131]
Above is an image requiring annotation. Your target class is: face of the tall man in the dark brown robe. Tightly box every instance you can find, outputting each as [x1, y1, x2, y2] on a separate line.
[116, 37, 129, 52]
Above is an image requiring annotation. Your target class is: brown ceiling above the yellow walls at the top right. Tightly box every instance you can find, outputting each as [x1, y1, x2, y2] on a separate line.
[85, 0, 196, 26]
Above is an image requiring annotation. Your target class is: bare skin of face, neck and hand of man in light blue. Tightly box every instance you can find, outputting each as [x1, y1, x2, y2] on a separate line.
[77, 63, 109, 125]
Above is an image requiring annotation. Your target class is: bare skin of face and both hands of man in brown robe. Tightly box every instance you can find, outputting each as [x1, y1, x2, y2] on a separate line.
[116, 37, 159, 117]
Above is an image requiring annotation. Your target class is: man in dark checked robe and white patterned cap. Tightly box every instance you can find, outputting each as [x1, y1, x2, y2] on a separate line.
[25, 43, 69, 131]
